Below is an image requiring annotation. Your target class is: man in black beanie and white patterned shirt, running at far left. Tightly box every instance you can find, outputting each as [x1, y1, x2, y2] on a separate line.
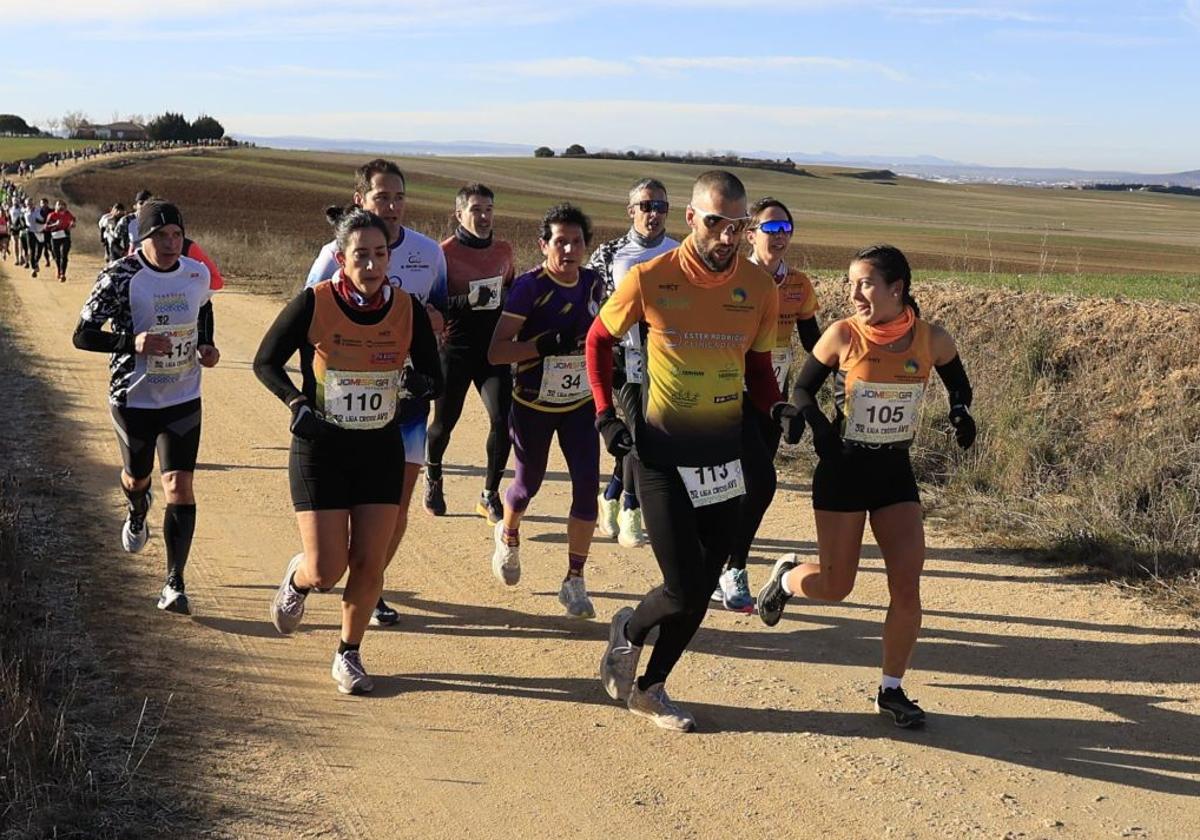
[73, 200, 221, 614]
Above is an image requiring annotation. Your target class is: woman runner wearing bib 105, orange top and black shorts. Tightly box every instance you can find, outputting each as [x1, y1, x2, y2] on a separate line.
[758, 245, 976, 727]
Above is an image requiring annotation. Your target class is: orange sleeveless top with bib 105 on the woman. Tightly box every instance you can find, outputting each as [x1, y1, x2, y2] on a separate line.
[832, 318, 934, 449]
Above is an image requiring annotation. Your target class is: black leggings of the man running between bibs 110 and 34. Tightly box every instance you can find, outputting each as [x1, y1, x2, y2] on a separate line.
[425, 346, 512, 493]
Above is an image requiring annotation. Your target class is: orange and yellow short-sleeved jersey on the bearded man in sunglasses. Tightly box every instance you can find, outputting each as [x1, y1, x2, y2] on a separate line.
[599, 236, 779, 467]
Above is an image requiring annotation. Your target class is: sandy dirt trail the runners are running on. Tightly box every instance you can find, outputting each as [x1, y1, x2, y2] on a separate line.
[0, 169, 1200, 839]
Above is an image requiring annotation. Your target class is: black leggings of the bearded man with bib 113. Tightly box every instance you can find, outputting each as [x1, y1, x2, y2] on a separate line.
[625, 461, 740, 690]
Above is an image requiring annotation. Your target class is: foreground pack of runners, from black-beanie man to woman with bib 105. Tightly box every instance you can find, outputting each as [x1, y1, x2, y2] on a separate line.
[68, 160, 974, 731]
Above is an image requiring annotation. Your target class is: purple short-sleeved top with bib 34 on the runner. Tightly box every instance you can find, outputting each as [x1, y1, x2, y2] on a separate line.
[504, 266, 604, 412]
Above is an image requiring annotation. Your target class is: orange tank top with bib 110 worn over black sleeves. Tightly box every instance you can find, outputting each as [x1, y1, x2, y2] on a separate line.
[308, 282, 413, 430]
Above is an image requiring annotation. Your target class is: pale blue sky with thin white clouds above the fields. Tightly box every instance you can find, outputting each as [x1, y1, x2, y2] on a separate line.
[0, 0, 1200, 172]
